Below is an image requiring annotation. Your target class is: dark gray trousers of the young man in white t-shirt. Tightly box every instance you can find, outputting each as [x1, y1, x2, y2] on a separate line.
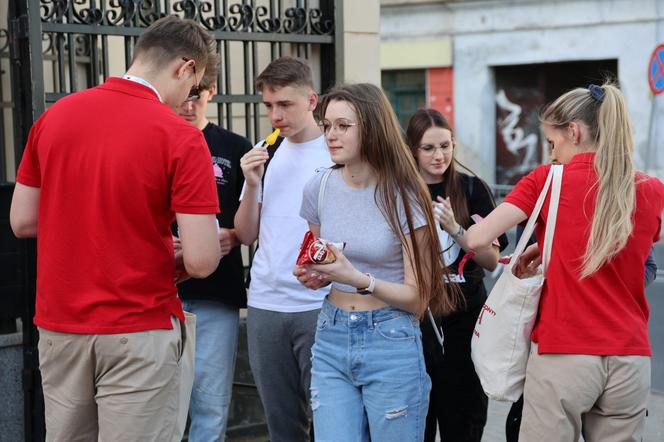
[247, 307, 320, 442]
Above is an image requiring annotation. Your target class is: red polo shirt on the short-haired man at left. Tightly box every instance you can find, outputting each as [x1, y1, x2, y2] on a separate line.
[16, 78, 219, 334]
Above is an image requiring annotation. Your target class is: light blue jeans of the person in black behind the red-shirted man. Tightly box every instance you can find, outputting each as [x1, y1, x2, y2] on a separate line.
[182, 301, 240, 442]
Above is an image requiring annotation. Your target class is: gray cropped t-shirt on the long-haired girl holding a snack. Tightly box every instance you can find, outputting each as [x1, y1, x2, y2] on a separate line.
[300, 168, 426, 292]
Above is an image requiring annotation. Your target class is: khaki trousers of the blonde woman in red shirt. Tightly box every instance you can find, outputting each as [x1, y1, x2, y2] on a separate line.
[519, 343, 650, 442]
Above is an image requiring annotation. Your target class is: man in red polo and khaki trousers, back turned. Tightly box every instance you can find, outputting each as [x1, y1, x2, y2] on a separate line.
[10, 17, 220, 442]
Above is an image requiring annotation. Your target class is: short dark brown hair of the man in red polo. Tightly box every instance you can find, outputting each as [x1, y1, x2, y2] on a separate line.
[132, 15, 218, 76]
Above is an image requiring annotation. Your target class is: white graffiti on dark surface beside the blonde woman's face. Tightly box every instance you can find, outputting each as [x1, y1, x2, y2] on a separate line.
[496, 88, 542, 184]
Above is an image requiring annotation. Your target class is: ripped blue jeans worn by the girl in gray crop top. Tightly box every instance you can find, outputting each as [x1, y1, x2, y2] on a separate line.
[311, 300, 431, 442]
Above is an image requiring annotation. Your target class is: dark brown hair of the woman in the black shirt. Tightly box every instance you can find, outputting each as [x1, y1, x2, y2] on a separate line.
[406, 109, 488, 228]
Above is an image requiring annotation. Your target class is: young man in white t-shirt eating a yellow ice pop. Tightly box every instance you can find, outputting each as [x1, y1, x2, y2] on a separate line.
[235, 57, 332, 442]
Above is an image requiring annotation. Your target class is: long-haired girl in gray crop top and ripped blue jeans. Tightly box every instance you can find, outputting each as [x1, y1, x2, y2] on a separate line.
[294, 84, 455, 441]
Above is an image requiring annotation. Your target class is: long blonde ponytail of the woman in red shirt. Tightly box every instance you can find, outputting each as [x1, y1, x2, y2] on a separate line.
[540, 82, 636, 278]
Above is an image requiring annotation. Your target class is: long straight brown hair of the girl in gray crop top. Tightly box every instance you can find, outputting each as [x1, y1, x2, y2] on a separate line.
[320, 83, 458, 317]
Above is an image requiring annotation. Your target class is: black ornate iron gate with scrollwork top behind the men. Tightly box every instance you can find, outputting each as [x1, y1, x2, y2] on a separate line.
[5, 0, 343, 441]
